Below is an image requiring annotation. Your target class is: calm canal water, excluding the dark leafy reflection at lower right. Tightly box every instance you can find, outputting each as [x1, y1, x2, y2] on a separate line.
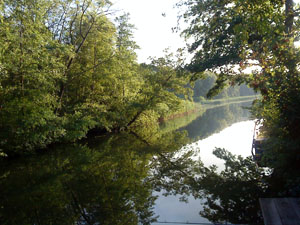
[0, 103, 253, 225]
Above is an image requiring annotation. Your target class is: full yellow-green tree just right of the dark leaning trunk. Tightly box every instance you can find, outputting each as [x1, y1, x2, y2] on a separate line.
[60, 16, 115, 135]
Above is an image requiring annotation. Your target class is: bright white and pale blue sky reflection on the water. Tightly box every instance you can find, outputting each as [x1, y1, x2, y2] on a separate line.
[153, 103, 254, 225]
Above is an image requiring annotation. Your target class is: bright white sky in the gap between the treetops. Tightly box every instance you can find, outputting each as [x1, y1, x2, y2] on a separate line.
[113, 0, 185, 63]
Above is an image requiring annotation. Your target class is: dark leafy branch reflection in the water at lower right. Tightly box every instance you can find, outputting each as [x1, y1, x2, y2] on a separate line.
[151, 148, 269, 224]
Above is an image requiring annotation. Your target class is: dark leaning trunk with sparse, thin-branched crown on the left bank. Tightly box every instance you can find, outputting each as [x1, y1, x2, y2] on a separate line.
[48, 0, 111, 113]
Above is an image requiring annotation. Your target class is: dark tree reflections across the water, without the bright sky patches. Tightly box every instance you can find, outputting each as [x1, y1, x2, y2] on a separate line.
[0, 102, 268, 225]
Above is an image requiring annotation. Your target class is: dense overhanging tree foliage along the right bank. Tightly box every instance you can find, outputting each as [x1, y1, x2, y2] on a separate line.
[179, 0, 300, 186]
